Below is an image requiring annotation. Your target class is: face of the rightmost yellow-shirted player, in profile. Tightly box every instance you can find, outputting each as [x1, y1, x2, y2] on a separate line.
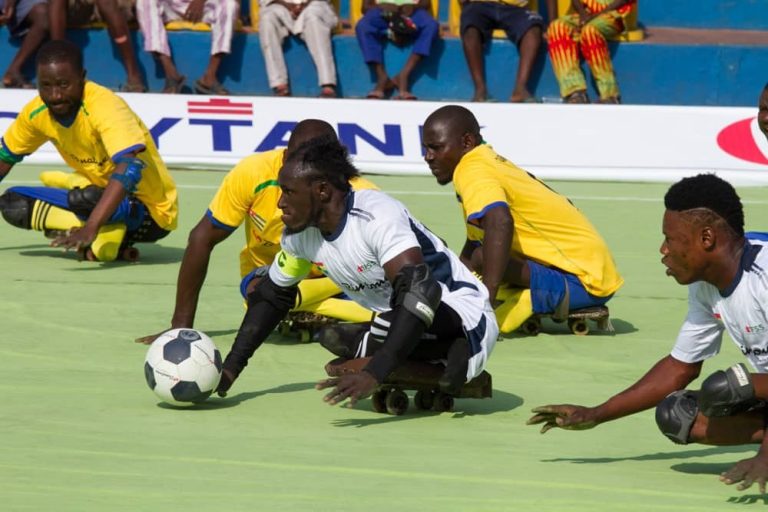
[422, 122, 470, 185]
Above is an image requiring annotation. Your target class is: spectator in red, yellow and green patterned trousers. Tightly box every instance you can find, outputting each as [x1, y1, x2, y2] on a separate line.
[547, 0, 635, 103]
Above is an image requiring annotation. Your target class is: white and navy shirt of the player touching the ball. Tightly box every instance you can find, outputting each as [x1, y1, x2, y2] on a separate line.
[269, 190, 499, 378]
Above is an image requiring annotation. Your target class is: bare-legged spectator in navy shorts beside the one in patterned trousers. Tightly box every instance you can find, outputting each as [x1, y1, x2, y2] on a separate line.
[459, 0, 557, 103]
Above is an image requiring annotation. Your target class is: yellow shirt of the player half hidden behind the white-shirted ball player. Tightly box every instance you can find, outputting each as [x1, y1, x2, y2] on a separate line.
[206, 148, 377, 277]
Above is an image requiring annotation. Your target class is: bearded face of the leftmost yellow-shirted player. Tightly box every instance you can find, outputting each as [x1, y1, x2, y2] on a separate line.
[37, 62, 85, 121]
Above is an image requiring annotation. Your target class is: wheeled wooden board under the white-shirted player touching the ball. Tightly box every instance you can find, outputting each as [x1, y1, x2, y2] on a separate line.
[325, 357, 493, 416]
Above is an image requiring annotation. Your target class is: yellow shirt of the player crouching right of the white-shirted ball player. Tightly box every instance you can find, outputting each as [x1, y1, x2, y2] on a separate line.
[453, 144, 624, 297]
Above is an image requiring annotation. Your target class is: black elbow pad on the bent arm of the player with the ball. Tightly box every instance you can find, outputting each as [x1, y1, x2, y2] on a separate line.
[390, 263, 443, 327]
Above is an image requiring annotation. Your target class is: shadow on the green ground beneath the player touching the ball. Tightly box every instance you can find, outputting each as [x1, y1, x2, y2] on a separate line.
[333, 389, 523, 428]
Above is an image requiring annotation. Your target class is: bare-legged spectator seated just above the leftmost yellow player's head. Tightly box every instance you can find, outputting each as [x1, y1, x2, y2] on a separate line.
[48, 0, 147, 92]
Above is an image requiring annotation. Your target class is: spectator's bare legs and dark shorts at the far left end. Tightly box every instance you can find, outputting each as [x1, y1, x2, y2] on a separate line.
[0, 0, 48, 89]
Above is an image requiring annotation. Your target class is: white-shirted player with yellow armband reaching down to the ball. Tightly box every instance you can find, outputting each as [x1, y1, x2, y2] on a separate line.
[218, 137, 498, 404]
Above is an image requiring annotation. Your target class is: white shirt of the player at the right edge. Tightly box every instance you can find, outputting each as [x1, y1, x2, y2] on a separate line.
[672, 233, 768, 373]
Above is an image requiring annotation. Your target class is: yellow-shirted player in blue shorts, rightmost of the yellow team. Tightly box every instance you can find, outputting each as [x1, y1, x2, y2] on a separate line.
[422, 105, 624, 332]
